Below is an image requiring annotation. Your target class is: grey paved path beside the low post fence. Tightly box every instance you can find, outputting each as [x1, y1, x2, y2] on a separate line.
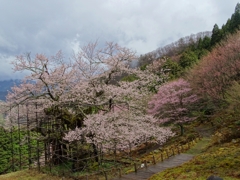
[113, 154, 193, 180]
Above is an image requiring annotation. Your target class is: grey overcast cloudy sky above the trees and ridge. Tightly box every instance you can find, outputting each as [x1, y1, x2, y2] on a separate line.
[0, 0, 238, 80]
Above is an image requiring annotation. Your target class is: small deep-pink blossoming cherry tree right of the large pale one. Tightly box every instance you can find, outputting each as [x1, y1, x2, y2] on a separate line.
[148, 78, 198, 135]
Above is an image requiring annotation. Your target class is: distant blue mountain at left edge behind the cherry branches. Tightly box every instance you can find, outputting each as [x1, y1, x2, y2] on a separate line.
[0, 79, 21, 101]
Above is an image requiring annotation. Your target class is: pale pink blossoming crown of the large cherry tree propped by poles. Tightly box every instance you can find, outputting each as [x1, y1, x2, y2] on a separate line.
[7, 42, 174, 162]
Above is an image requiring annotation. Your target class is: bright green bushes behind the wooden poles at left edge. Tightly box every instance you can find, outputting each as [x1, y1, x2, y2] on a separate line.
[0, 127, 41, 174]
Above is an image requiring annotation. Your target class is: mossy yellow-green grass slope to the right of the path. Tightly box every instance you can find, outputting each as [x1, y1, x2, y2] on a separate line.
[150, 125, 240, 180]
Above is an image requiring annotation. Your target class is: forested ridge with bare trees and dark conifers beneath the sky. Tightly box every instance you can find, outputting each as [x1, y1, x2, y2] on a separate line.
[138, 4, 240, 79]
